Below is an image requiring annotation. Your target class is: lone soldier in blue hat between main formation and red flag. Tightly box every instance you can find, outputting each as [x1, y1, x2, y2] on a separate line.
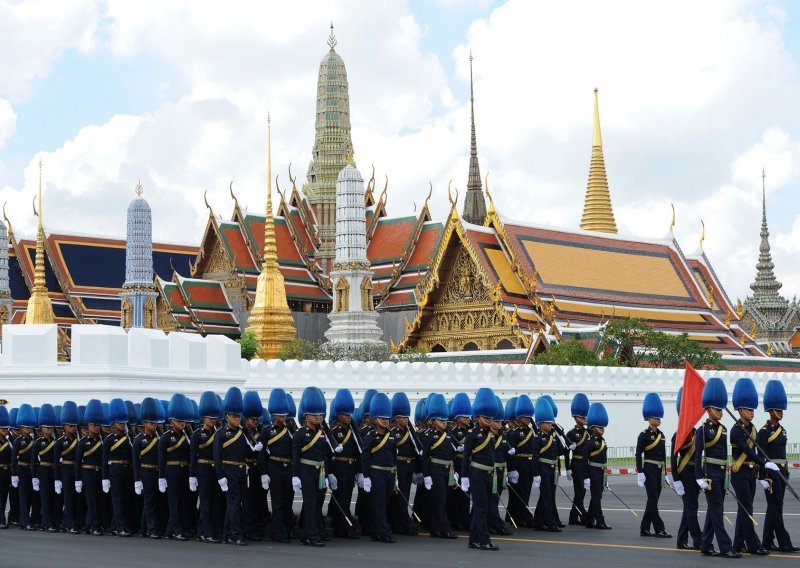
[636, 392, 672, 538]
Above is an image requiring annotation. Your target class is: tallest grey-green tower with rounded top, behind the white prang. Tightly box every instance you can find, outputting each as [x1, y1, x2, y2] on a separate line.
[303, 27, 353, 272]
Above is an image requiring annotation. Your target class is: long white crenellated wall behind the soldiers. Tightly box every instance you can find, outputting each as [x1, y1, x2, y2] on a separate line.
[0, 325, 800, 446]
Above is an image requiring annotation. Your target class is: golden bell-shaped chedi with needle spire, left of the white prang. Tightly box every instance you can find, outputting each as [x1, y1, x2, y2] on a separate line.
[247, 118, 297, 359]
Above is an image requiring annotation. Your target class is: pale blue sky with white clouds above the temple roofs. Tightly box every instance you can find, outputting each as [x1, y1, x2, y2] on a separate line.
[0, 0, 800, 301]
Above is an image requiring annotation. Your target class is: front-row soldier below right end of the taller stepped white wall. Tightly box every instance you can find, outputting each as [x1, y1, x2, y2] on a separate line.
[214, 387, 248, 546]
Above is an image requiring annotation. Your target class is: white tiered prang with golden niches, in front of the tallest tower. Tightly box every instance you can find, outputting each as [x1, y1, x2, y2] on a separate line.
[325, 164, 382, 346]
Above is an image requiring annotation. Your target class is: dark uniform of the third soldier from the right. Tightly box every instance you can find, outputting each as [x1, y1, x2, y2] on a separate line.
[694, 420, 732, 553]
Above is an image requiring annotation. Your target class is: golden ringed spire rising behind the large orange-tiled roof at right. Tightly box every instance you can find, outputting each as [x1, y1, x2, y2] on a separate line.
[581, 88, 617, 233]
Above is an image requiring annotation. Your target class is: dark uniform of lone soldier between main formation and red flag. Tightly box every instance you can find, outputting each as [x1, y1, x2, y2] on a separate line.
[636, 426, 668, 534]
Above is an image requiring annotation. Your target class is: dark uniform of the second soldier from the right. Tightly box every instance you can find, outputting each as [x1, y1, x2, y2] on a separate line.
[731, 421, 767, 551]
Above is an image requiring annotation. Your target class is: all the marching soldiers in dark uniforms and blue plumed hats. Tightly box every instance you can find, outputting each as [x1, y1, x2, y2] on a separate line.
[0, 379, 800, 557]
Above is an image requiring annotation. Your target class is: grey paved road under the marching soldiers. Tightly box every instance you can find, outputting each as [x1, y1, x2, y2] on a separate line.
[0, 475, 800, 568]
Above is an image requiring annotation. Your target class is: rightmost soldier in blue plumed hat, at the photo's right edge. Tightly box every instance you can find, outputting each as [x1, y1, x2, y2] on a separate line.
[758, 379, 800, 552]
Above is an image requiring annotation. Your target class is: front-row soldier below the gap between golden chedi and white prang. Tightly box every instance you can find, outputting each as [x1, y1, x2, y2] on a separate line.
[292, 387, 338, 546]
